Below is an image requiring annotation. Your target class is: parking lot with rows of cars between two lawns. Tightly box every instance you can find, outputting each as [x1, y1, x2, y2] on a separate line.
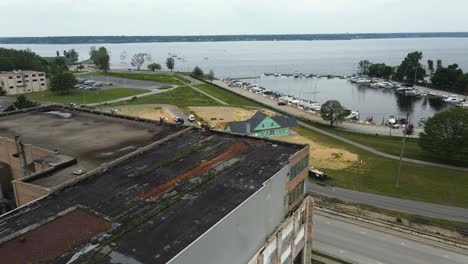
[78, 76, 167, 90]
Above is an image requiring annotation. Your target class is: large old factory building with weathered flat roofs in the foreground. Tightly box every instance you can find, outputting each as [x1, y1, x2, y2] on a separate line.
[0, 106, 313, 264]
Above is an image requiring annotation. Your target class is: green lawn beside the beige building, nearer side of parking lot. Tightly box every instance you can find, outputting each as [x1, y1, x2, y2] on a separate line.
[22, 88, 149, 104]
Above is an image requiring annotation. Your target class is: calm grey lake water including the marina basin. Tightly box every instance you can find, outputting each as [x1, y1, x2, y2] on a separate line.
[0, 38, 468, 122]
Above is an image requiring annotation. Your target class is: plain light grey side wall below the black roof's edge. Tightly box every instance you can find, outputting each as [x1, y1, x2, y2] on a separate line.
[168, 166, 290, 264]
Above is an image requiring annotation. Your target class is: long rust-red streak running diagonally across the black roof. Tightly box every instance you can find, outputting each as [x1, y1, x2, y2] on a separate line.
[137, 142, 247, 200]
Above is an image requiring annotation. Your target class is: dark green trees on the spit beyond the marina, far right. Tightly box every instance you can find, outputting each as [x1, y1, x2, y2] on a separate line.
[358, 51, 468, 94]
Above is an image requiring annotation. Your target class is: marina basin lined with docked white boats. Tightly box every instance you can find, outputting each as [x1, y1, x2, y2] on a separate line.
[225, 73, 466, 128]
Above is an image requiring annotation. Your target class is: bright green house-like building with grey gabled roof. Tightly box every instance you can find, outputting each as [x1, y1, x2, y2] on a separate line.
[224, 111, 297, 138]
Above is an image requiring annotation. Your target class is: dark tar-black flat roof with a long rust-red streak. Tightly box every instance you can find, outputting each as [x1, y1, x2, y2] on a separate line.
[0, 119, 305, 263]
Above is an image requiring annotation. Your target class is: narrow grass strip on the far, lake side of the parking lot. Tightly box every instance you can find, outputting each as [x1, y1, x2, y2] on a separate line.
[79, 72, 190, 85]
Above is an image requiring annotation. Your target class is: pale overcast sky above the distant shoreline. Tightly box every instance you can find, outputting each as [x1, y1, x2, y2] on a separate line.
[0, 0, 468, 37]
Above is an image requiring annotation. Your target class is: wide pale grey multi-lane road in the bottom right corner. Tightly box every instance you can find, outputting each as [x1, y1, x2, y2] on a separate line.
[313, 214, 468, 264]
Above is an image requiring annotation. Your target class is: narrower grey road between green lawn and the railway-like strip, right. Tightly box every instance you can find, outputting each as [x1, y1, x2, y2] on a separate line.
[308, 181, 468, 224]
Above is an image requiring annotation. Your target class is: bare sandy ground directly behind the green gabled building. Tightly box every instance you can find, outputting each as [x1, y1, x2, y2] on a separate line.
[190, 107, 273, 129]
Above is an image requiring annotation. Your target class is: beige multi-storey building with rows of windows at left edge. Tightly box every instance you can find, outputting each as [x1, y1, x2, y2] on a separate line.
[0, 71, 48, 96]
